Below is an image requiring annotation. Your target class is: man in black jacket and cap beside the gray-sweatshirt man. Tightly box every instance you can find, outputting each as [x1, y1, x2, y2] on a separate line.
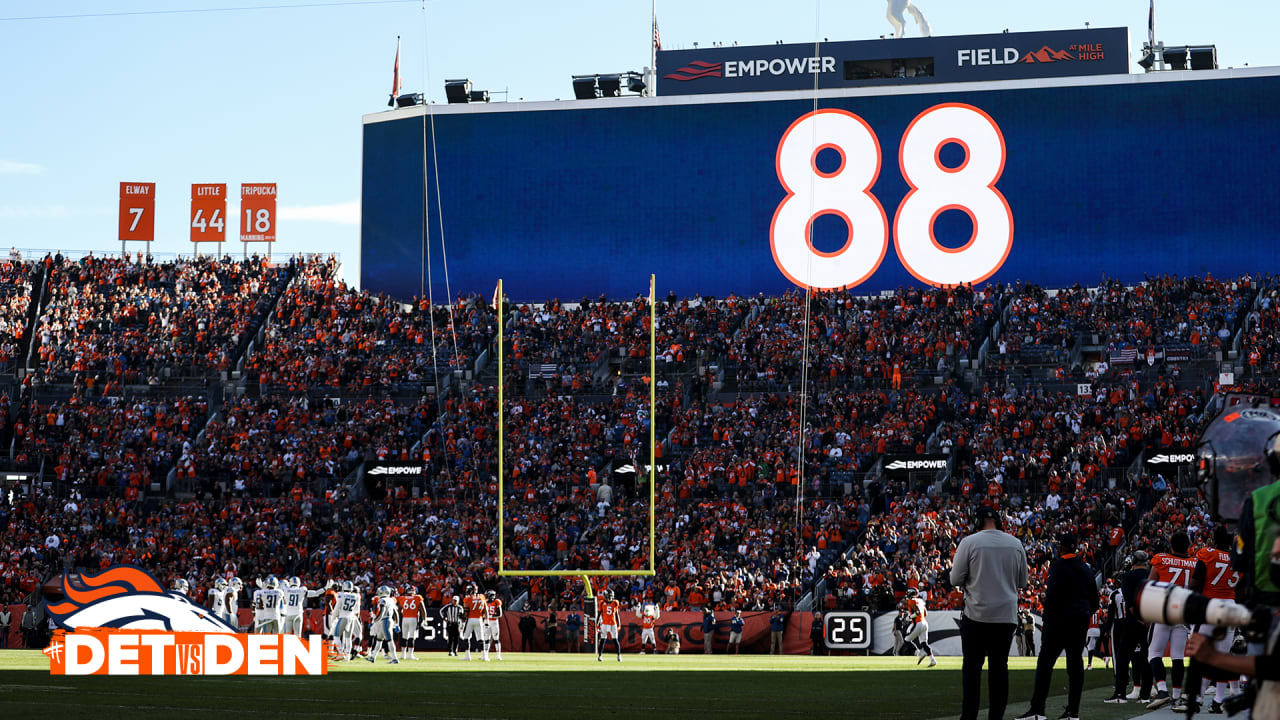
[1019, 533, 1098, 720]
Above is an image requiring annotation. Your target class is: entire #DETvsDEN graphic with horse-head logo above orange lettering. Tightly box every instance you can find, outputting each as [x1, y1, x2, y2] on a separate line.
[44, 565, 329, 675]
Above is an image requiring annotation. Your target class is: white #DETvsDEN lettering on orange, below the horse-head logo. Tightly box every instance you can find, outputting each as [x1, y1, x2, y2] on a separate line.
[44, 628, 329, 675]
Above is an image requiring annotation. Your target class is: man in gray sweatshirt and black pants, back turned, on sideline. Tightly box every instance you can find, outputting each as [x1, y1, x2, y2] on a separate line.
[951, 506, 1028, 720]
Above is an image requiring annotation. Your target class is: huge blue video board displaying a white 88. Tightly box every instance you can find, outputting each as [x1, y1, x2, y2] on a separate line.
[361, 68, 1280, 301]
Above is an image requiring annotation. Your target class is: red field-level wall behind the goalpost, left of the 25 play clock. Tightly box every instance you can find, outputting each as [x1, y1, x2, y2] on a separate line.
[500, 612, 822, 655]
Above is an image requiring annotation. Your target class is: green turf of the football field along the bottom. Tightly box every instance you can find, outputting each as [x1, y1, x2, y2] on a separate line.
[0, 651, 1162, 720]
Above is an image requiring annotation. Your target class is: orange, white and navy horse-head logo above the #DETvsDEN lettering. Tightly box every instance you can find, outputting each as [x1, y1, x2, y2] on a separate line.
[45, 565, 238, 633]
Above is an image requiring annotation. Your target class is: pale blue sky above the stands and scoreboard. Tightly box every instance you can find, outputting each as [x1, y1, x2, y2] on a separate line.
[0, 0, 1280, 282]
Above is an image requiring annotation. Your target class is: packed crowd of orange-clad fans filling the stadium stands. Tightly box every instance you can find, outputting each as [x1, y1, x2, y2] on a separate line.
[0, 258, 1277, 648]
